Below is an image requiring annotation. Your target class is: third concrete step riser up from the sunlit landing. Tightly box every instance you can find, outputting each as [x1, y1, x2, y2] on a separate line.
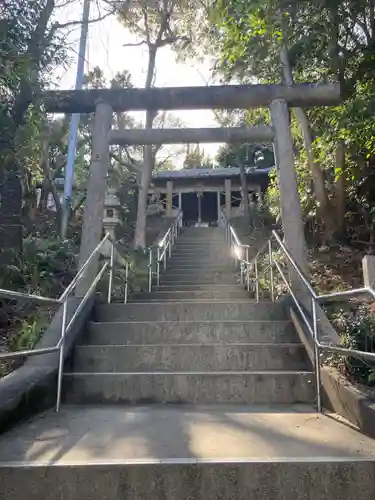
[85, 321, 299, 345]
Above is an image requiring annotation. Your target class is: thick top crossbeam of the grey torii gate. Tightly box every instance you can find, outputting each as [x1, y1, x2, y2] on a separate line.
[41, 83, 341, 114]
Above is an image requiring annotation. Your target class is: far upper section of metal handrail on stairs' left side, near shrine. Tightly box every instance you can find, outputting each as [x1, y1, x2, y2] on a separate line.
[148, 210, 183, 292]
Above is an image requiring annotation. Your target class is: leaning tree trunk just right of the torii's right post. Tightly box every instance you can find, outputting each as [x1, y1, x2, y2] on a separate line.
[280, 45, 335, 237]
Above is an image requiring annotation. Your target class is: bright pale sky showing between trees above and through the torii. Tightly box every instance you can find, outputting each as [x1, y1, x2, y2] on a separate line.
[56, 0, 225, 162]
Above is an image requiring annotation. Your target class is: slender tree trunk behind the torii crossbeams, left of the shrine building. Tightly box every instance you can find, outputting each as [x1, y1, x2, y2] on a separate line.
[134, 45, 157, 250]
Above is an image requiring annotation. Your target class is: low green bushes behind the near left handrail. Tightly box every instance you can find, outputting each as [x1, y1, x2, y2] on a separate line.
[0, 236, 78, 376]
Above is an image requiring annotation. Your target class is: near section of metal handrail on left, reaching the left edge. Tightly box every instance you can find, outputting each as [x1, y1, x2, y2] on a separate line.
[0, 234, 129, 412]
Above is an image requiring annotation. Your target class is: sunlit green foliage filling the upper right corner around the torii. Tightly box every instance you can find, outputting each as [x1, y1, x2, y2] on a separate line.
[212, 0, 375, 239]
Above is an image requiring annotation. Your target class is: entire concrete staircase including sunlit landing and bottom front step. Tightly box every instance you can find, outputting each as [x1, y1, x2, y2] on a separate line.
[0, 228, 375, 500]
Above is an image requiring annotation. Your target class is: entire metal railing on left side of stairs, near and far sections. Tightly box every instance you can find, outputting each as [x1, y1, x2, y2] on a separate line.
[0, 212, 182, 412]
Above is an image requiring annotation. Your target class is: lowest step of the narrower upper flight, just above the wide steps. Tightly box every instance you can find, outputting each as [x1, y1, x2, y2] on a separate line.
[131, 286, 253, 302]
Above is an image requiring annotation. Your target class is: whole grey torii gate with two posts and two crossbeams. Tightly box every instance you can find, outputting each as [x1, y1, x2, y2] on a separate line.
[42, 84, 341, 295]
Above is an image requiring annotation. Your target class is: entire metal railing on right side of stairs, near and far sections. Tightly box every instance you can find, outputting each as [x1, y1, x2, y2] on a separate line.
[222, 209, 375, 412]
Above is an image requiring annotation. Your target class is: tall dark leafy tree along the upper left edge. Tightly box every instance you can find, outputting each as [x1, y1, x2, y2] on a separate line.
[0, 0, 114, 262]
